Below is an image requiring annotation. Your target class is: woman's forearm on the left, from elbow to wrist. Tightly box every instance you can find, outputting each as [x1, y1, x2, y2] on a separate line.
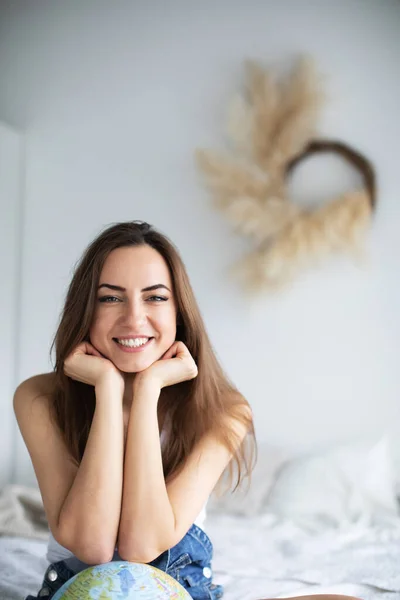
[57, 379, 123, 564]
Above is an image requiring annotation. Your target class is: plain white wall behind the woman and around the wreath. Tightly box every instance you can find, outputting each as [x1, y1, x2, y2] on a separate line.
[0, 0, 400, 480]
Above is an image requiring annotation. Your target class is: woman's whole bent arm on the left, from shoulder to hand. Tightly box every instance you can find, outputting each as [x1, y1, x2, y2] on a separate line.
[14, 344, 123, 564]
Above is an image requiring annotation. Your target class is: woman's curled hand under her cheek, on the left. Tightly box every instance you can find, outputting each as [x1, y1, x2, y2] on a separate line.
[64, 342, 124, 386]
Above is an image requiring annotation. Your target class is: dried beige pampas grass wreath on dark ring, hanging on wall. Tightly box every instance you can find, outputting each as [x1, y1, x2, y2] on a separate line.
[196, 59, 376, 291]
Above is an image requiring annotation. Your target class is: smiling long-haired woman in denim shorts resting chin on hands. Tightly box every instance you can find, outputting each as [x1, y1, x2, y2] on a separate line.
[14, 222, 254, 600]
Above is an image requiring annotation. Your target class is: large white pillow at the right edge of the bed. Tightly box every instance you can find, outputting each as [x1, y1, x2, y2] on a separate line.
[266, 437, 398, 531]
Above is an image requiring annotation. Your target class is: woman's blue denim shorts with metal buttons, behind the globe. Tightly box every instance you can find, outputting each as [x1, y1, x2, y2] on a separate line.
[25, 525, 223, 600]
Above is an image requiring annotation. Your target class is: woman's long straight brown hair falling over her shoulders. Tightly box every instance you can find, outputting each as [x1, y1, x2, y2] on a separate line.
[52, 221, 255, 486]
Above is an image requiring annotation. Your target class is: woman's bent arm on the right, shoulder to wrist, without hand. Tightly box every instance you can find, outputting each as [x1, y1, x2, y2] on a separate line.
[118, 342, 246, 562]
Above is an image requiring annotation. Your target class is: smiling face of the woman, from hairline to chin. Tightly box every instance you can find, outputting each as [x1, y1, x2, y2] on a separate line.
[90, 245, 176, 373]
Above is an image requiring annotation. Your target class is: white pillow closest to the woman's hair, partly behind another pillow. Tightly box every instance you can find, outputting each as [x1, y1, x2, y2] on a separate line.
[207, 443, 288, 517]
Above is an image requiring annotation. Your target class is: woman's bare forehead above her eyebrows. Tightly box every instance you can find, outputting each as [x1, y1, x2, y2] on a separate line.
[99, 246, 172, 289]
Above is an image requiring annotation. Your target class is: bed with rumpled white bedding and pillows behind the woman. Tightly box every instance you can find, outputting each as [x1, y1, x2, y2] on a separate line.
[0, 440, 400, 600]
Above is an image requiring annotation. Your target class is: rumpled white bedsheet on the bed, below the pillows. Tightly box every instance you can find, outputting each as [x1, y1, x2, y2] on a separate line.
[0, 515, 400, 600]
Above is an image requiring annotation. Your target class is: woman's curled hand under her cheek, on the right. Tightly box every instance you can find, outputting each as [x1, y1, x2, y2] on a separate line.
[135, 342, 198, 389]
